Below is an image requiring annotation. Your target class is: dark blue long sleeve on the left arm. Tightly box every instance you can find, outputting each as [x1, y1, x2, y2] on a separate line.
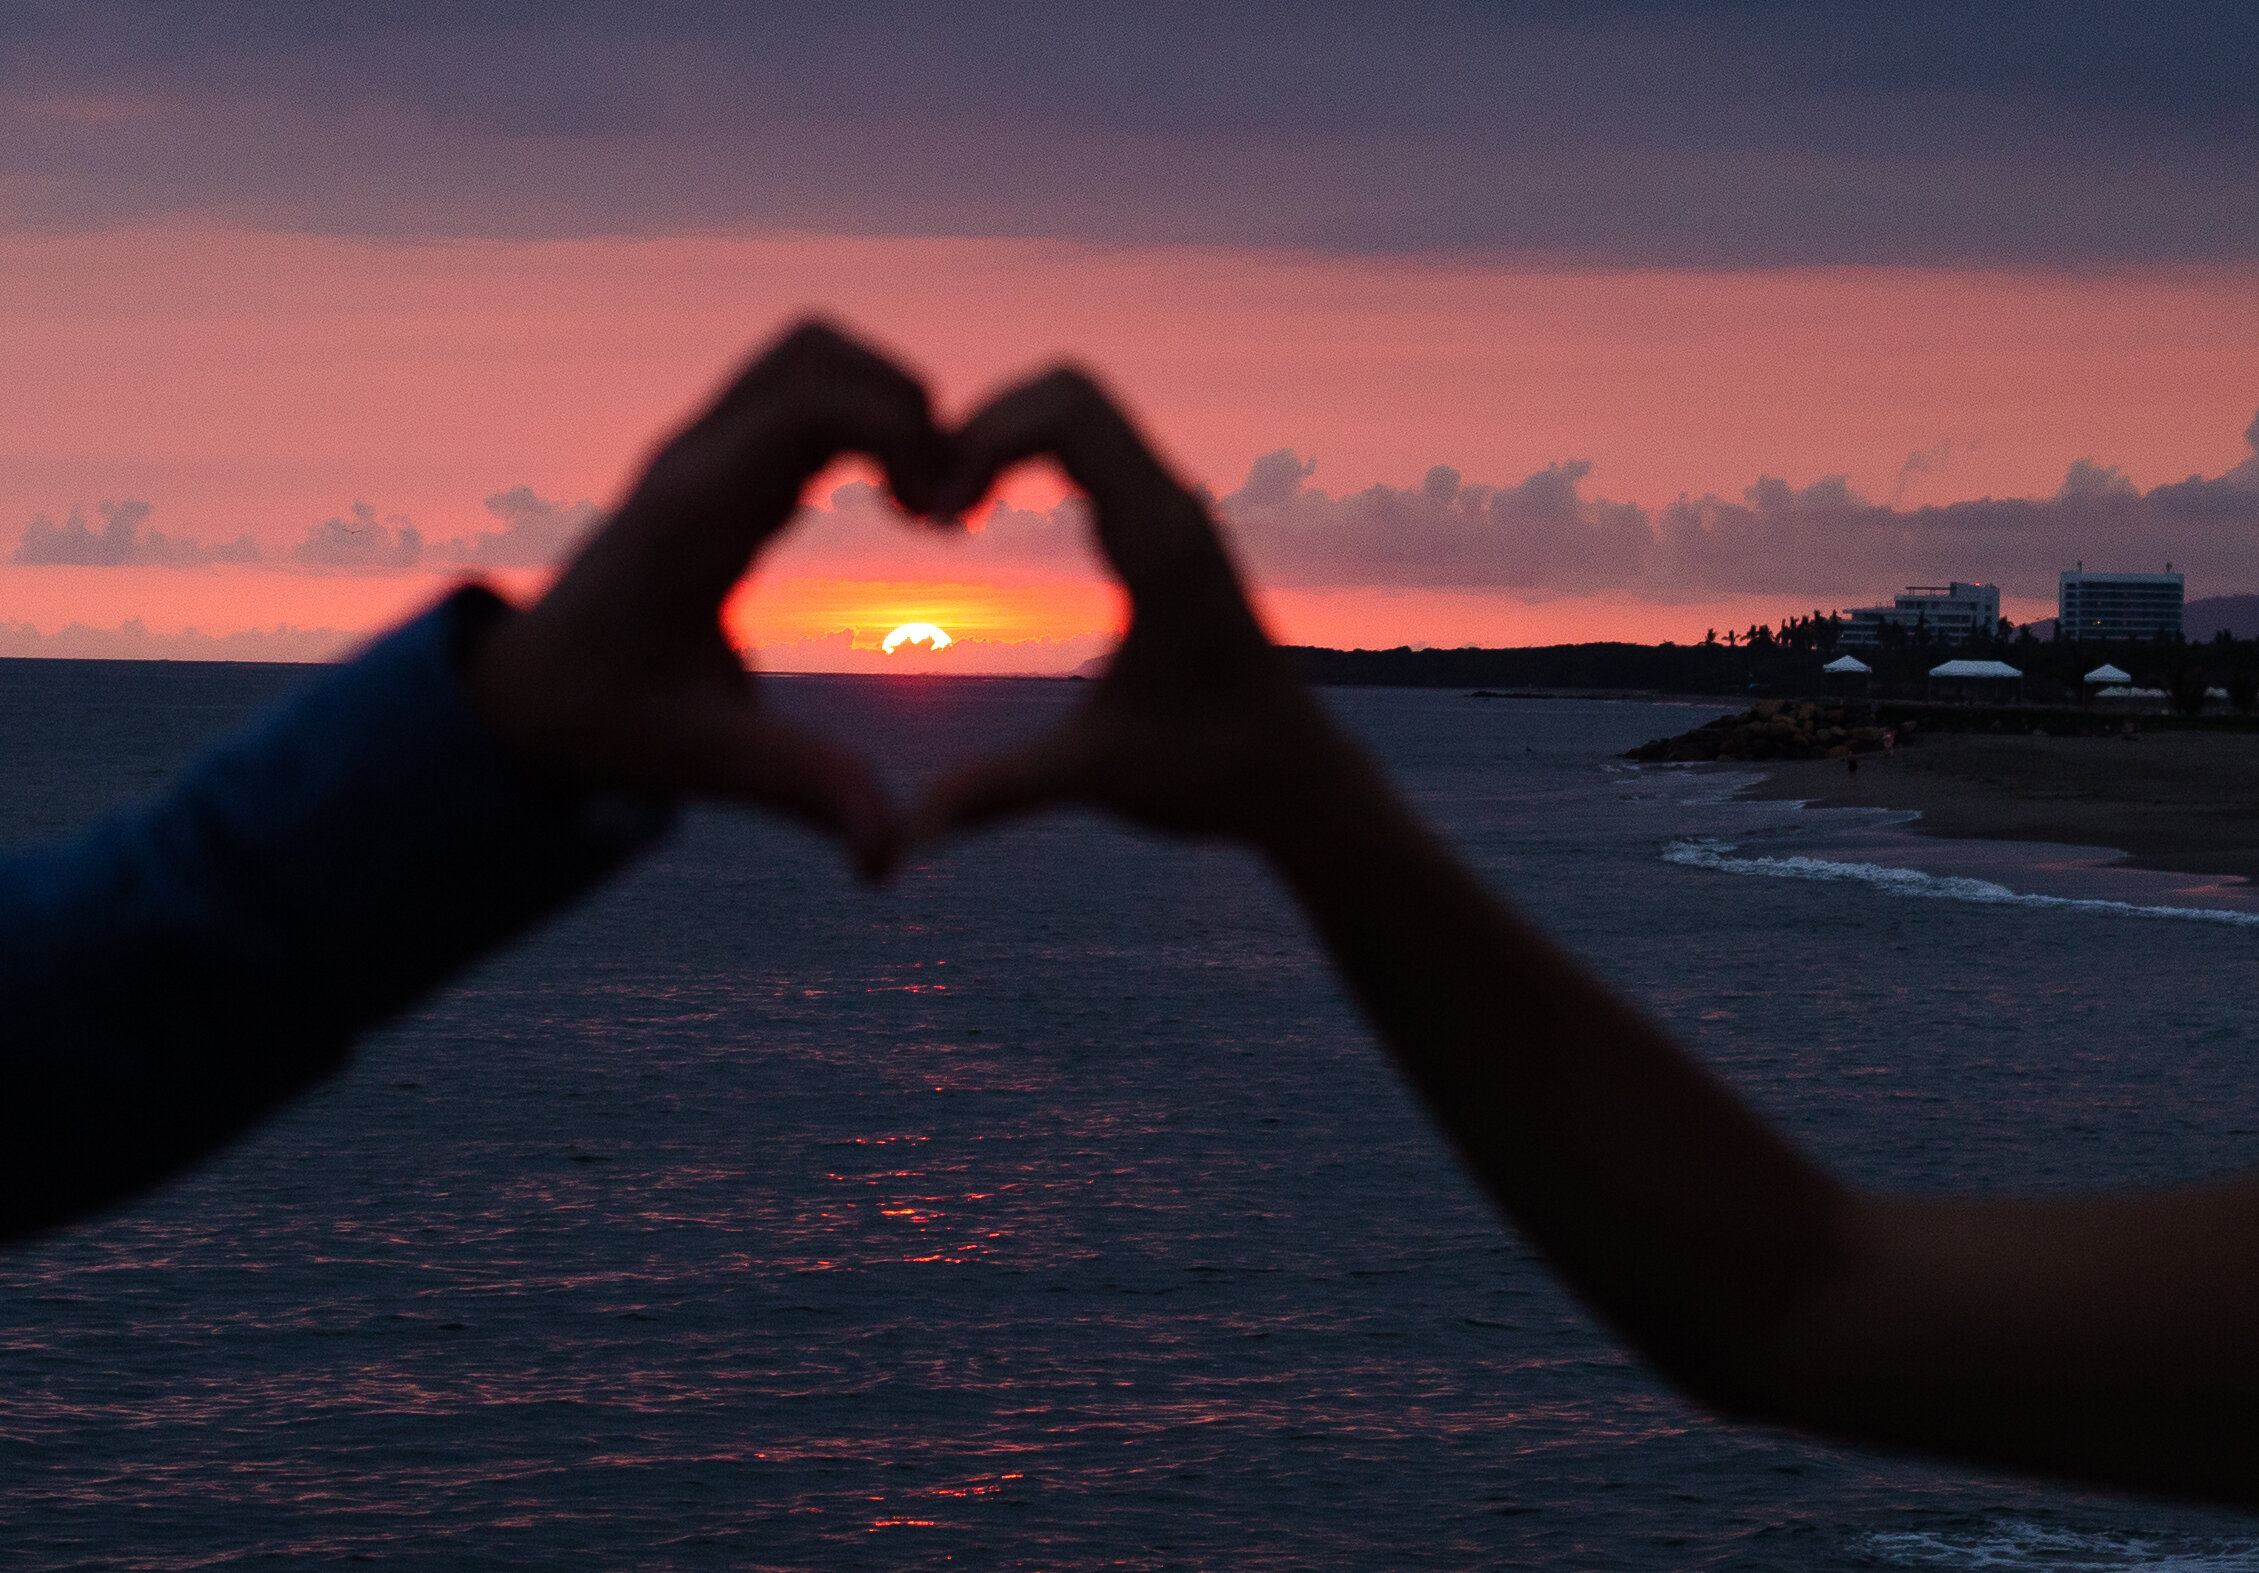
[0, 588, 671, 1239]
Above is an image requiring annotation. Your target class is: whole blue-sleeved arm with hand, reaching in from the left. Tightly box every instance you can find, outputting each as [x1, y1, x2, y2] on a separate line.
[0, 328, 947, 1239]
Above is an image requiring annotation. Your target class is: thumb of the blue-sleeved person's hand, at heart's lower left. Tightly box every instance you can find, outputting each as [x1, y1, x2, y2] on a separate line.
[684, 712, 904, 879]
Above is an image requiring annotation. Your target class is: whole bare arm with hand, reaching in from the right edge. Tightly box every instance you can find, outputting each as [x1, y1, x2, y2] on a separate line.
[919, 373, 2259, 1501]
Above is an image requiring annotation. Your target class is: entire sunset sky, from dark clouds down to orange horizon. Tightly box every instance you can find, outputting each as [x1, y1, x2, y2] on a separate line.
[0, 0, 2259, 671]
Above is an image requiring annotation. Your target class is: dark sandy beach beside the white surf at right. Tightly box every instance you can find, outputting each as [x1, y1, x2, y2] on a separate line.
[1742, 732, 2259, 879]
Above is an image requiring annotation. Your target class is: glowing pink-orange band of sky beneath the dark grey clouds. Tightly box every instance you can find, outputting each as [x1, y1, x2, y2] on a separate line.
[0, 226, 2259, 669]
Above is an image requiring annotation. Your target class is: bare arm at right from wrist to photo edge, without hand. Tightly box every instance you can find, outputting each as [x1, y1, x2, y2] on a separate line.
[1263, 762, 2259, 1503]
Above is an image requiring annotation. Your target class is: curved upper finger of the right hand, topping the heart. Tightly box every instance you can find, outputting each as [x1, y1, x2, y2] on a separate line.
[933, 368, 1242, 603]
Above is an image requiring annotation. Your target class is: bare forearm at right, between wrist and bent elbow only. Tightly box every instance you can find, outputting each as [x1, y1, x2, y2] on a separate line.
[1263, 757, 1850, 1406]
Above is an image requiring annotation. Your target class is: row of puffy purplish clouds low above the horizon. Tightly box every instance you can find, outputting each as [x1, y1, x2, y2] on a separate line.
[16, 418, 2259, 601]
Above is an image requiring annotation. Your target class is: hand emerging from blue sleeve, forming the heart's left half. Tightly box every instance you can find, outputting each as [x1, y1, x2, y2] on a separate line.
[470, 323, 949, 875]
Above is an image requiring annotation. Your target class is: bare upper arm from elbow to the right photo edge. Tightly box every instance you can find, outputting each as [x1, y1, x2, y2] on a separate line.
[1767, 1175, 2259, 1505]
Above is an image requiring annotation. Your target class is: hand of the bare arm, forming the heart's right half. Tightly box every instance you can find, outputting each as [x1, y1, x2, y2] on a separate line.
[913, 371, 1369, 845]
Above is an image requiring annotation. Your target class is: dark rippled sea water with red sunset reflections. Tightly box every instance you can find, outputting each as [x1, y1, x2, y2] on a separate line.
[0, 662, 2259, 1568]
